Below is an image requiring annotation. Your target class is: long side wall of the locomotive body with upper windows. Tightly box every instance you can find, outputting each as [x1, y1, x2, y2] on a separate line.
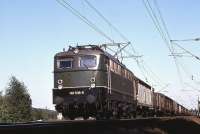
[108, 58, 136, 103]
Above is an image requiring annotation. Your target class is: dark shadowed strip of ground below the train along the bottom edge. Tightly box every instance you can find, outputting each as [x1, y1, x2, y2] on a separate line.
[0, 117, 200, 134]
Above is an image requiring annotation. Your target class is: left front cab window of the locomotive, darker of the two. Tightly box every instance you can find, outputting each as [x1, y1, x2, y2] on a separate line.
[57, 58, 73, 69]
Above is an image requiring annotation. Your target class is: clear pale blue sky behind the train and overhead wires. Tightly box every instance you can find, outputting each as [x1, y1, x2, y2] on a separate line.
[0, 0, 200, 109]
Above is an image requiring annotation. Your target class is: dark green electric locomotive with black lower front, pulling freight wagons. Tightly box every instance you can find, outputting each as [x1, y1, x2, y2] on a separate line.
[53, 45, 136, 119]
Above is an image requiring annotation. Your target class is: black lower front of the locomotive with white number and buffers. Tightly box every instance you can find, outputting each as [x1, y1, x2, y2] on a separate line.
[53, 88, 106, 117]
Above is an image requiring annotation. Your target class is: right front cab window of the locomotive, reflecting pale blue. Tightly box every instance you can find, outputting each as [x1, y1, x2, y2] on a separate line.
[80, 55, 97, 68]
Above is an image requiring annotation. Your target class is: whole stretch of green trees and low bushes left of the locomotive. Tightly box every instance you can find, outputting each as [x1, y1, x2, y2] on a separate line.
[0, 76, 56, 123]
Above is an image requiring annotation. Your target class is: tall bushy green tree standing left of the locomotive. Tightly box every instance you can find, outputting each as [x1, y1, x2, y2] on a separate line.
[5, 76, 32, 122]
